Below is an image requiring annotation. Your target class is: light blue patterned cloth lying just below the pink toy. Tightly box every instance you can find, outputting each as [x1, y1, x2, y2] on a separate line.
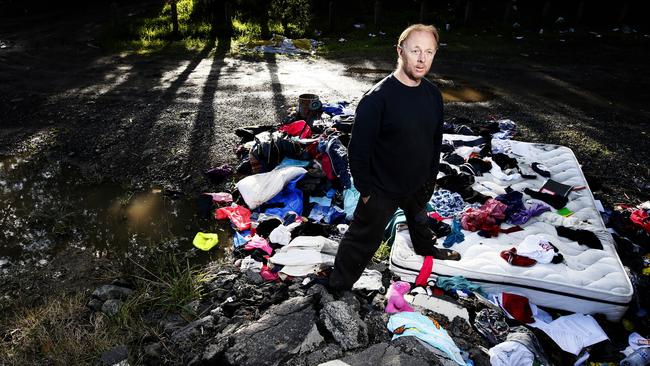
[387, 312, 466, 366]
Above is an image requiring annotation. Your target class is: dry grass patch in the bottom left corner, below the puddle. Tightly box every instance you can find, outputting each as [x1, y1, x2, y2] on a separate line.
[0, 254, 207, 365]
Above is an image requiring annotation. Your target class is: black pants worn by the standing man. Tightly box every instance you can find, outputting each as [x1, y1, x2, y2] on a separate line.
[329, 192, 437, 290]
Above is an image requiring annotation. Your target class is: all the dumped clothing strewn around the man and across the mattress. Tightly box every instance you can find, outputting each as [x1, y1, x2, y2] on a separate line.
[194, 98, 650, 365]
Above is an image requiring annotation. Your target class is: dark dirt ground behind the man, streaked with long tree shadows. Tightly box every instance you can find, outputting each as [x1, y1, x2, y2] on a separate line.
[0, 4, 650, 352]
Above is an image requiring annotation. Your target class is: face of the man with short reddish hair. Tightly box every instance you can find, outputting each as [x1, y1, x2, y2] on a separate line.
[397, 31, 436, 81]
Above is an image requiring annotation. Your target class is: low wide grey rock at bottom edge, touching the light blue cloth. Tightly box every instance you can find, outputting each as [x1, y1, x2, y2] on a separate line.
[320, 337, 456, 366]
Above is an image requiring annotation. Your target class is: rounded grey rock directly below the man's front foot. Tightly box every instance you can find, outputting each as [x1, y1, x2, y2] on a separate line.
[320, 300, 368, 351]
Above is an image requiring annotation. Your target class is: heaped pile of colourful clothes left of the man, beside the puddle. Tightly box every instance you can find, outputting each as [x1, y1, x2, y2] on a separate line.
[195, 102, 364, 288]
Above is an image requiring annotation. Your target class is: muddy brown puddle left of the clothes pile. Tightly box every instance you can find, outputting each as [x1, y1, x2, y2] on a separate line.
[0, 153, 230, 269]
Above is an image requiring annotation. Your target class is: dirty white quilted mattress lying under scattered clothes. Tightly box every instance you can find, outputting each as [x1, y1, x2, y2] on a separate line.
[390, 135, 633, 321]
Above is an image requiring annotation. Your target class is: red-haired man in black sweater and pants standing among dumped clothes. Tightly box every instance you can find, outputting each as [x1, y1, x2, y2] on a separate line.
[329, 24, 460, 290]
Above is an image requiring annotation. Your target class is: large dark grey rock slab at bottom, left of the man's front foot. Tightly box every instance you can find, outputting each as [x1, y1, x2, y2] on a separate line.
[224, 297, 316, 366]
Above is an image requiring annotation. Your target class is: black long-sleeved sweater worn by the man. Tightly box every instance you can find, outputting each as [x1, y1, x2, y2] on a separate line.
[349, 74, 443, 198]
